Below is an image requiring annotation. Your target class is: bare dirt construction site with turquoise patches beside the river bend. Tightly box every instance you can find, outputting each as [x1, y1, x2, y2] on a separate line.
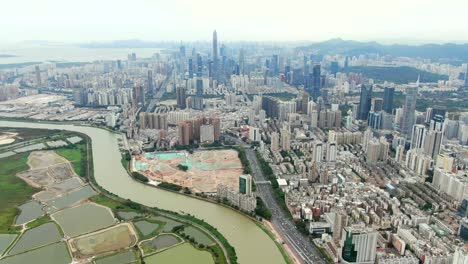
[132, 150, 243, 193]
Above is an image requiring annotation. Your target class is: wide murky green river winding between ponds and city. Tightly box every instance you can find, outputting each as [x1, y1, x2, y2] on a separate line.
[0, 121, 284, 264]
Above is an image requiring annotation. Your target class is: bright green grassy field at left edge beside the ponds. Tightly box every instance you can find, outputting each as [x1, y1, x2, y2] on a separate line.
[0, 153, 39, 233]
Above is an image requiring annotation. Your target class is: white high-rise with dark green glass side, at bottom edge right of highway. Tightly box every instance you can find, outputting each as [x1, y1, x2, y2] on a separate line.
[341, 226, 377, 264]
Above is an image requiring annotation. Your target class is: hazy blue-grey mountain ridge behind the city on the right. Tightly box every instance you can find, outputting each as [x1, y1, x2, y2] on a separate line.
[300, 38, 468, 63]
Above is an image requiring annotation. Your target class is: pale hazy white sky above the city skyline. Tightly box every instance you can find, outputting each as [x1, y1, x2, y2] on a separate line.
[0, 0, 468, 44]
